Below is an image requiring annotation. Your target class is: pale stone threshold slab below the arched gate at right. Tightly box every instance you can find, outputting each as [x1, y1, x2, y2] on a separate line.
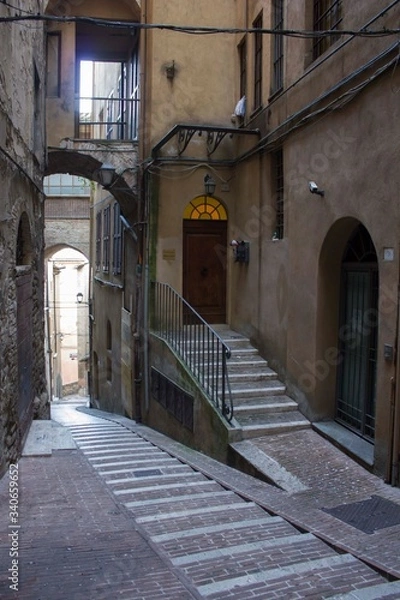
[312, 421, 374, 467]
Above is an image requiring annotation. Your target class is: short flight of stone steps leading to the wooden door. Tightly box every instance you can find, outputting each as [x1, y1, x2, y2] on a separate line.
[213, 325, 311, 439]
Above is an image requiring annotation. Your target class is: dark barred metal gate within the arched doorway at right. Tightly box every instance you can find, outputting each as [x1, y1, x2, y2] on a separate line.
[336, 225, 379, 440]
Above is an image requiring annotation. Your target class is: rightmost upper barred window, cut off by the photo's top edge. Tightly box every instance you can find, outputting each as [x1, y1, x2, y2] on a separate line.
[313, 0, 342, 59]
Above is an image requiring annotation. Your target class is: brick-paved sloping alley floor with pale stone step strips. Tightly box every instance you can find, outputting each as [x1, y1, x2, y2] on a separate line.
[0, 402, 400, 600]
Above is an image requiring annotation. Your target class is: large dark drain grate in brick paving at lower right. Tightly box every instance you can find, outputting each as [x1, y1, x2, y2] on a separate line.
[323, 496, 400, 533]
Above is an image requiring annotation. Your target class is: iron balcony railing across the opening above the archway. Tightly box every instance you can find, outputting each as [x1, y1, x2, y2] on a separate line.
[76, 97, 139, 140]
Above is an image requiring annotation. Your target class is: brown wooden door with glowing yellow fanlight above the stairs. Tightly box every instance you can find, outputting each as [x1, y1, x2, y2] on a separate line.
[183, 196, 227, 323]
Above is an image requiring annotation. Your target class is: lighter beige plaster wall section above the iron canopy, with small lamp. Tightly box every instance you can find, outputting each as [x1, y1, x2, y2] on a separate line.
[141, 0, 239, 154]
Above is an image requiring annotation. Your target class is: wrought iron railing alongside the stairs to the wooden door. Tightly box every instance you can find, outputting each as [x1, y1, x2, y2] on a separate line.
[152, 282, 233, 422]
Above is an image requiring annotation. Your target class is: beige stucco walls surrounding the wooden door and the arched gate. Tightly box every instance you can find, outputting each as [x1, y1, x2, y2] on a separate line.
[142, 1, 399, 477]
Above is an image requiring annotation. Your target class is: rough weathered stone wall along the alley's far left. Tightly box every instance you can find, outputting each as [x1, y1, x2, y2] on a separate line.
[0, 0, 49, 476]
